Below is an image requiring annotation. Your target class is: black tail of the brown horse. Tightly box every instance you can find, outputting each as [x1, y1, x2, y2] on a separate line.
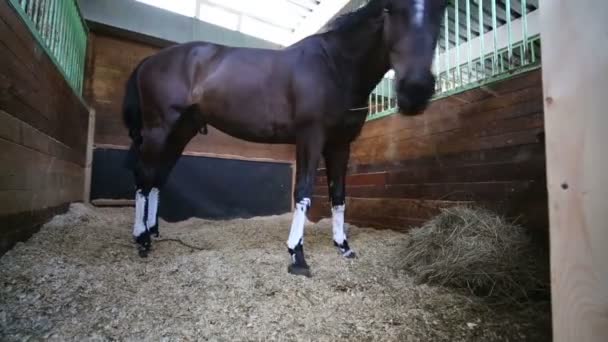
[122, 58, 146, 169]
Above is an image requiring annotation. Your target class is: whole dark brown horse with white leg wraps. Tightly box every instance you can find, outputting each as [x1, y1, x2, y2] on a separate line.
[124, 0, 446, 275]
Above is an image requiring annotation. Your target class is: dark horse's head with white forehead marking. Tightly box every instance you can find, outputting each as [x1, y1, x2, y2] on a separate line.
[384, 0, 447, 115]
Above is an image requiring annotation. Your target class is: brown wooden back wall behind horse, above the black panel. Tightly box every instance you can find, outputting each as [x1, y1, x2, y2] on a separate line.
[85, 31, 294, 162]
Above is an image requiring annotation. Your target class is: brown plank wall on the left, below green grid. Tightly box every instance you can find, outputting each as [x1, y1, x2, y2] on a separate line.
[0, 1, 89, 253]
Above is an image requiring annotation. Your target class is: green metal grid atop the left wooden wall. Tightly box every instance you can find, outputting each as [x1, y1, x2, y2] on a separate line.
[9, 0, 88, 98]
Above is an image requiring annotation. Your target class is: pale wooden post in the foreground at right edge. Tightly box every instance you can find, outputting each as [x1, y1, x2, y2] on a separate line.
[539, 0, 608, 342]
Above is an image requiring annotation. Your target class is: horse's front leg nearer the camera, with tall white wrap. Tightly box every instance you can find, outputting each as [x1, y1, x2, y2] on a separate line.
[287, 127, 324, 277]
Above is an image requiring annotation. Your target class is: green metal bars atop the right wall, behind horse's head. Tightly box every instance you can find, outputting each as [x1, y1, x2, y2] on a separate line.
[367, 0, 541, 120]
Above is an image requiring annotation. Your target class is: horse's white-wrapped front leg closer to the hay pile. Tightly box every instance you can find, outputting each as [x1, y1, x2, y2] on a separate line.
[323, 143, 356, 258]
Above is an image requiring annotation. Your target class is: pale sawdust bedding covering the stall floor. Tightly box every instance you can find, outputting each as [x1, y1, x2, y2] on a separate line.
[0, 204, 550, 341]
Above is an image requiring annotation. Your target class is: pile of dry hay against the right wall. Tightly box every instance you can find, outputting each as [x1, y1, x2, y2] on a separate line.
[403, 206, 549, 303]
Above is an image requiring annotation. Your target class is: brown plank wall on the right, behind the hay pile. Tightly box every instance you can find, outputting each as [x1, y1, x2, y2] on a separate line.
[311, 70, 547, 229]
